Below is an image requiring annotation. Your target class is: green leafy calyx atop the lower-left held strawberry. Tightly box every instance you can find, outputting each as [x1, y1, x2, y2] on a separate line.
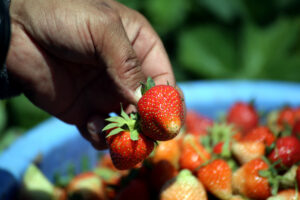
[102, 106, 139, 141]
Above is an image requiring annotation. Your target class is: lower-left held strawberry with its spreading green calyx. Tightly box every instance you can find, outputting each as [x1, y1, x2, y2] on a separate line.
[103, 109, 154, 170]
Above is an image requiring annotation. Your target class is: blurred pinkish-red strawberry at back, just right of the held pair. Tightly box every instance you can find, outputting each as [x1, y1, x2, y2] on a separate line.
[185, 110, 213, 136]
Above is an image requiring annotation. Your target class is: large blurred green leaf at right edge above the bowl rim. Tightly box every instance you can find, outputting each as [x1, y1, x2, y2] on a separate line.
[240, 18, 300, 80]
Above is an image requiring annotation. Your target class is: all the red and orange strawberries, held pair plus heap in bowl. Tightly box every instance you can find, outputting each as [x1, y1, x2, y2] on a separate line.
[19, 80, 300, 200]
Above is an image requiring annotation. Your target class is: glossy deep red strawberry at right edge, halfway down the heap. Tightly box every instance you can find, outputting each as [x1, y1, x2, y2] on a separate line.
[268, 136, 300, 167]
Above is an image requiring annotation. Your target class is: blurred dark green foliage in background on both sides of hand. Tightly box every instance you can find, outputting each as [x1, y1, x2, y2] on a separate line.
[0, 0, 300, 151]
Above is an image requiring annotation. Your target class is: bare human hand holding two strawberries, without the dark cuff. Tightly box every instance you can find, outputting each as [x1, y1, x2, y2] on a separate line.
[6, 0, 175, 149]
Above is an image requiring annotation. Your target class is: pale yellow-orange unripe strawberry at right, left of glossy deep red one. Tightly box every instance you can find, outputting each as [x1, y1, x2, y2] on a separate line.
[231, 141, 266, 164]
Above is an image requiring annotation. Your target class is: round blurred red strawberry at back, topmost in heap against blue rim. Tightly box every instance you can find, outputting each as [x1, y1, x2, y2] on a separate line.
[227, 102, 259, 133]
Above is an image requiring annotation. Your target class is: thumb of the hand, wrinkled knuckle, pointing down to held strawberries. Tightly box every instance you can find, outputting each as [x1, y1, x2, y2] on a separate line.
[92, 11, 146, 104]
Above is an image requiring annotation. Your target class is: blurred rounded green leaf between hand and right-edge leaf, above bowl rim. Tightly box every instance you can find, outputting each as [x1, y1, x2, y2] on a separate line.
[177, 25, 237, 78]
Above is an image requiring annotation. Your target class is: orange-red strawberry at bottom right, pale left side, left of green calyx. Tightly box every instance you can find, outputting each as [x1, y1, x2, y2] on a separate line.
[232, 158, 271, 199]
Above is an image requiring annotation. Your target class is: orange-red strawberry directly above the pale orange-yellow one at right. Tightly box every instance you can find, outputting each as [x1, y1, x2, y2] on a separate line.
[242, 126, 276, 146]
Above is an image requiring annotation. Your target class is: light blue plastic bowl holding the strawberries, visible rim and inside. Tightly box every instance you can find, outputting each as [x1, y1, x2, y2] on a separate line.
[0, 81, 300, 199]
